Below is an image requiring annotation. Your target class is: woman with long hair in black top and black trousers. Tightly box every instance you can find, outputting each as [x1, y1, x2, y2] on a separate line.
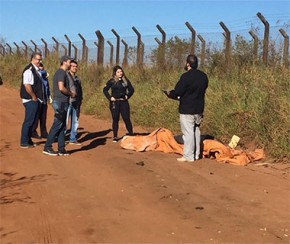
[103, 65, 134, 142]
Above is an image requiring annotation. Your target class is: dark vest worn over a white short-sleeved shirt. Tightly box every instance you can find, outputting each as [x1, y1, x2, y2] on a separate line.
[20, 63, 43, 100]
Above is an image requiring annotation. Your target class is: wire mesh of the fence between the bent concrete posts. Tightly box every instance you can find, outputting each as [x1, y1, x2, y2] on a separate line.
[2, 15, 290, 65]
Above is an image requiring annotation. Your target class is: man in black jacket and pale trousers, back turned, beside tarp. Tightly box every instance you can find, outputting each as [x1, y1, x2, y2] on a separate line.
[170, 55, 208, 162]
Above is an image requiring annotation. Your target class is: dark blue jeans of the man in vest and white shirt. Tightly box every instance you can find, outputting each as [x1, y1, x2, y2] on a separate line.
[20, 100, 39, 145]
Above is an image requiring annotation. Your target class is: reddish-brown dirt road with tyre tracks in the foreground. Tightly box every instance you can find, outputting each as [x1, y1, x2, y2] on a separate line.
[0, 86, 290, 243]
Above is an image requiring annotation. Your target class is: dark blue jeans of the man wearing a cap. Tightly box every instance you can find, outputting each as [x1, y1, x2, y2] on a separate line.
[44, 101, 68, 151]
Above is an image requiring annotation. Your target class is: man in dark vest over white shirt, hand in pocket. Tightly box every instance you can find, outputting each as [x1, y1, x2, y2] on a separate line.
[20, 52, 43, 148]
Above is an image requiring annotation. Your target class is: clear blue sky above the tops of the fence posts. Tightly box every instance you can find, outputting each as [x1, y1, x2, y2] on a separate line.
[0, 0, 290, 44]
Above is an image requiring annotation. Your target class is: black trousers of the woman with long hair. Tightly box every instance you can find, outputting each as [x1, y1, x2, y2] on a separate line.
[110, 101, 133, 137]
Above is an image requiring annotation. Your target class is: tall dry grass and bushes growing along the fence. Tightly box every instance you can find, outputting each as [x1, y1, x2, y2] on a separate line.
[0, 36, 290, 159]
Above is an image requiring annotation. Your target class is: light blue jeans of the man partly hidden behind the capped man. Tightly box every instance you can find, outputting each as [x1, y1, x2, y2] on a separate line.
[66, 102, 80, 142]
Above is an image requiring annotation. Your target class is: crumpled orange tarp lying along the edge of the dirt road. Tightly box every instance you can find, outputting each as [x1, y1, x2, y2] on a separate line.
[121, 128, 265, 165]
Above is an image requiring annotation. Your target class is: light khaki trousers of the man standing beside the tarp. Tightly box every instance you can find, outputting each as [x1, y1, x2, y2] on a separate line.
[179, 114, 202, 160]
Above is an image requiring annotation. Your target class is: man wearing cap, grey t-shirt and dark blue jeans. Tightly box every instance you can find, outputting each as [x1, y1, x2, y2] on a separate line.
[43, 56, 76, 156]
